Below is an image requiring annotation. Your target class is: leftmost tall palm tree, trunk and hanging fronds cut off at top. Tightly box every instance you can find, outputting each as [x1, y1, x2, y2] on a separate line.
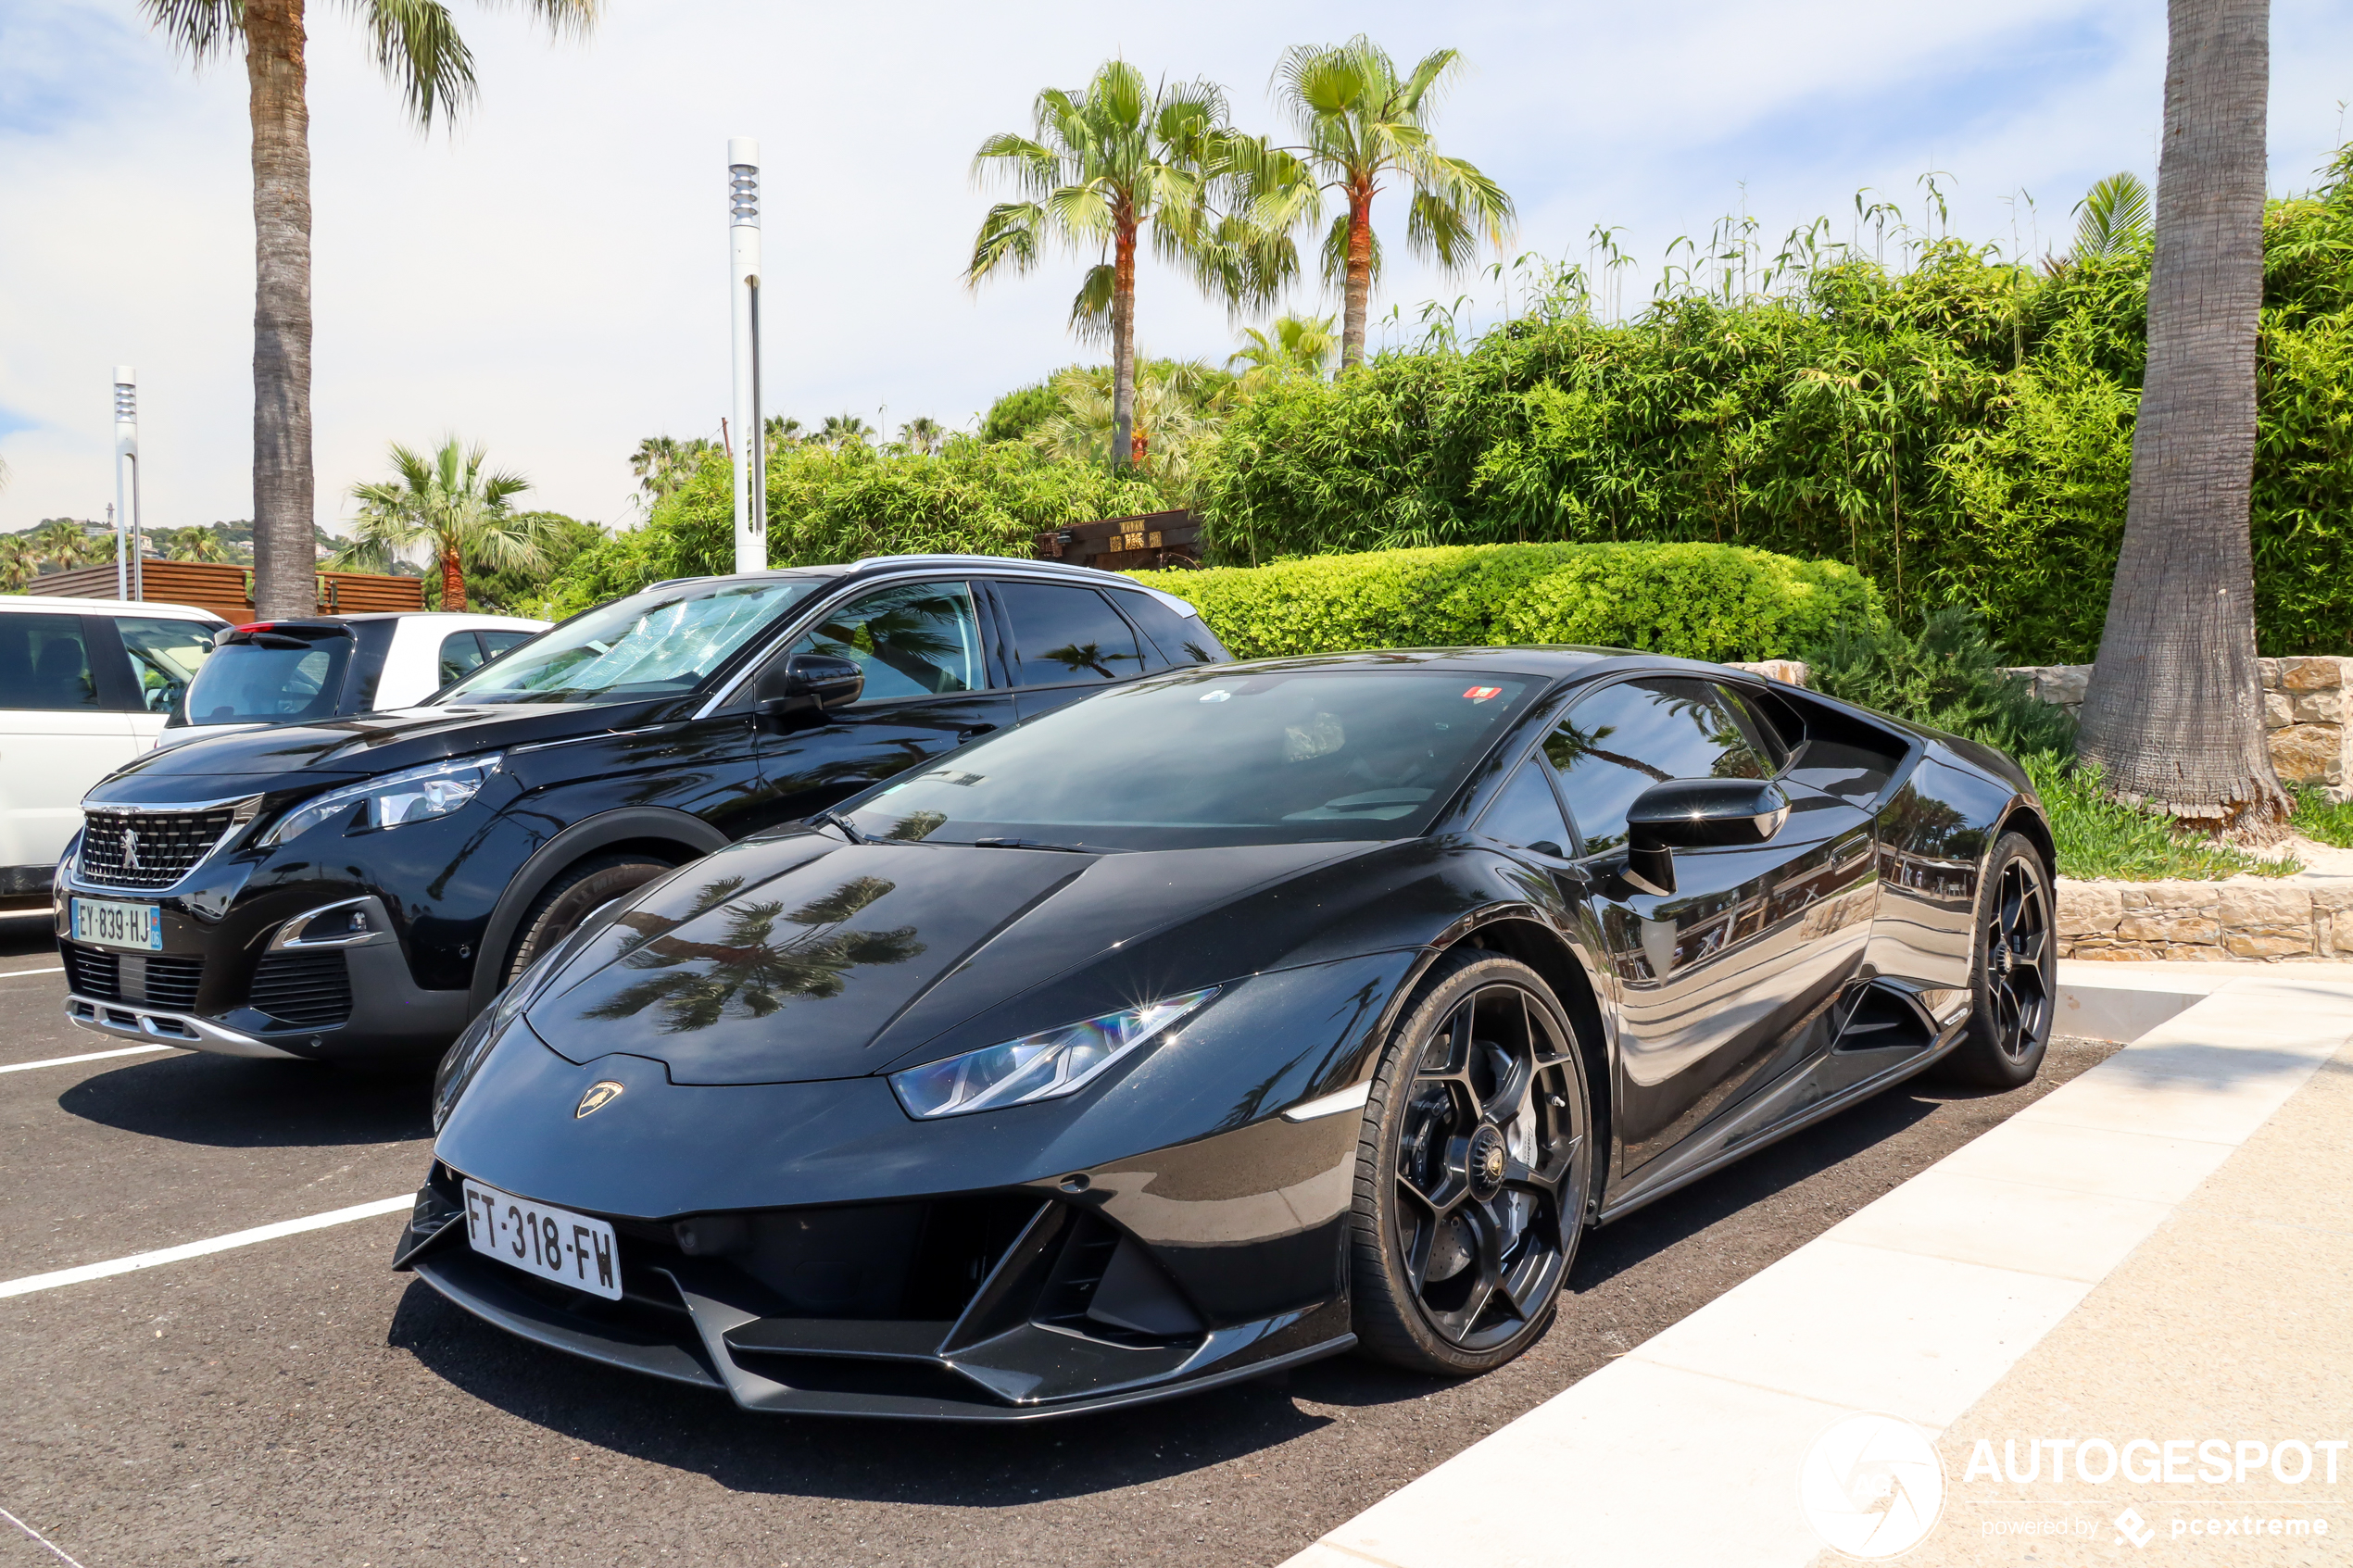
[139, 0, 598, 616]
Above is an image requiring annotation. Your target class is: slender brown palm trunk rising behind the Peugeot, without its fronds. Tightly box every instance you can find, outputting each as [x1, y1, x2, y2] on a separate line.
[245, 0, 318, 619]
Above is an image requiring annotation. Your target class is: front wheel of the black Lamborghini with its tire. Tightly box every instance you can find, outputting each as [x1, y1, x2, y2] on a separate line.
[1348, 947, 1593, 1377]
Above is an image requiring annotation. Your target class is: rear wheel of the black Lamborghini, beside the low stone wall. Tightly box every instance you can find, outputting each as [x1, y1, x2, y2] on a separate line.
[1936, 833, 2059, 1088]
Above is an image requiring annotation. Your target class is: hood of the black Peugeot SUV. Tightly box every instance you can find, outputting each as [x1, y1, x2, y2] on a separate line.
[90, 700, 673, 799]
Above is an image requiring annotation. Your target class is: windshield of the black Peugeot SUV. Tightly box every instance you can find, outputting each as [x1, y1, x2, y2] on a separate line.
[431, 578, 816, 705]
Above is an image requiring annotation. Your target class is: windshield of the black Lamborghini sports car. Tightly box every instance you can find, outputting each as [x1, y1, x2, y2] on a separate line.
[849, 665, 1541, 848]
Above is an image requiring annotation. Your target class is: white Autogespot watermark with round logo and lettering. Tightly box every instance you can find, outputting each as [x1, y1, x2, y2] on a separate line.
[1798, 1412, 2353, 1561]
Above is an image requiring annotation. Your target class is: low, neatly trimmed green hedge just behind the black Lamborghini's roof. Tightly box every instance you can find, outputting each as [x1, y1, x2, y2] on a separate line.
[1132, 543, 1885, 659]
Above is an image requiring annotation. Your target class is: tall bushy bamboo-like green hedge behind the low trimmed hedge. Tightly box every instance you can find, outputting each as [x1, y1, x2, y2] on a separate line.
[1195, 148, 2353, 663]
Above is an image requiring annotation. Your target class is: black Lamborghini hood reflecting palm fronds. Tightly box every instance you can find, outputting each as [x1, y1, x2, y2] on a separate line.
[527, 833, 1369, 1084]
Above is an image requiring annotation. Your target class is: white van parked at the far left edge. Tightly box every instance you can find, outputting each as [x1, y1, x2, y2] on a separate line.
[0, 595, 228, 905]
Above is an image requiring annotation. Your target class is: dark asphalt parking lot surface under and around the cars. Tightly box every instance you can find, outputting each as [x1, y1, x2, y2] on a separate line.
[0, 917, 2113, 1568]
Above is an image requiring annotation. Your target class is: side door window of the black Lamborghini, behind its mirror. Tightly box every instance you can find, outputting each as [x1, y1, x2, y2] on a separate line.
[1543, 680, 1774, 856]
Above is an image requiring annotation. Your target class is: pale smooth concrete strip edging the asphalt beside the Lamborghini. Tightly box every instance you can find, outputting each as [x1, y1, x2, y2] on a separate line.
[1287, 964, 2353, 1568]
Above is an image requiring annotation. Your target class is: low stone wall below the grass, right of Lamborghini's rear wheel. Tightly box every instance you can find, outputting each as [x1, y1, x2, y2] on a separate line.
[2059, 877, 2353, 964]
